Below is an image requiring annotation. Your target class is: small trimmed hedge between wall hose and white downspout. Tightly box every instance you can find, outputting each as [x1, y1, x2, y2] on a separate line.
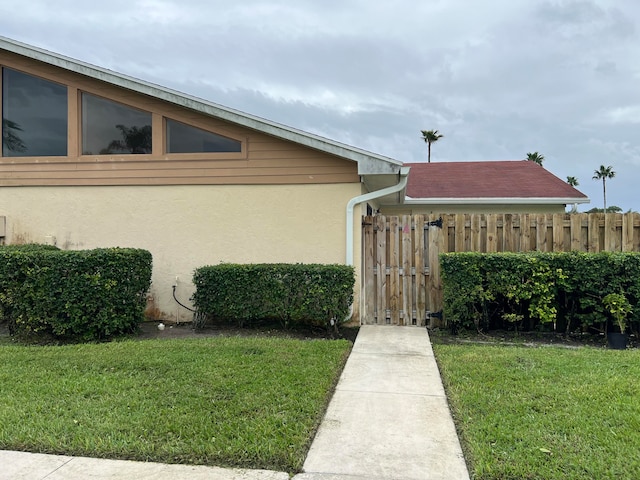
[192, 264, 355, 330]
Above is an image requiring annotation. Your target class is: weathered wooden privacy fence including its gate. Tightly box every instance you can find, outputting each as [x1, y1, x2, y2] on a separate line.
[362, 213, 640, 326]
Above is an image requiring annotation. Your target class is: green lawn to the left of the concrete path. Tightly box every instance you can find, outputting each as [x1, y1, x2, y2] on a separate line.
[0, 337, 351, 472]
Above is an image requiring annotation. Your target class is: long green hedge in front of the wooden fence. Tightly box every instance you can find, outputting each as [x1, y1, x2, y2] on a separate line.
[440, 252, 640, 333]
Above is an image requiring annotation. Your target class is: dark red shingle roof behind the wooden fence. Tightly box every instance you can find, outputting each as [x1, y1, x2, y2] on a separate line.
[405, 160, 587, 199]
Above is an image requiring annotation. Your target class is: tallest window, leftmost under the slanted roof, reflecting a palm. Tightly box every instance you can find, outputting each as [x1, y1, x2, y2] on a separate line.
[2, 68, 67, 157]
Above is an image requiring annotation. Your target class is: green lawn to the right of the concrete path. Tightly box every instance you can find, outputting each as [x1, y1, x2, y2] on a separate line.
[433, 344, 640, 480]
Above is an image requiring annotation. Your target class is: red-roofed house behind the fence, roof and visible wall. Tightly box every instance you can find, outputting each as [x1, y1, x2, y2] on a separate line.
[380, 160, 589, 214]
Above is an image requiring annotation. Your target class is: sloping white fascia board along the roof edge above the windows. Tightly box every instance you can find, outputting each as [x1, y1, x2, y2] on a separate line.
[0, 36, 402, 175]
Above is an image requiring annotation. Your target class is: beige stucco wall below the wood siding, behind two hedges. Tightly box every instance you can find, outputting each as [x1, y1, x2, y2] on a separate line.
[0, 183, 361, 322]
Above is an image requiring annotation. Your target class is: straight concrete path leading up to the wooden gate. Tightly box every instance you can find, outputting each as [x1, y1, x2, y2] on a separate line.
[295, 326, 469, 480]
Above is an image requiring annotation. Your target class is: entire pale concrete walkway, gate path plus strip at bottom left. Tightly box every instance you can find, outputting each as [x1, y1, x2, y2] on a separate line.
[0, 326, 469, 480]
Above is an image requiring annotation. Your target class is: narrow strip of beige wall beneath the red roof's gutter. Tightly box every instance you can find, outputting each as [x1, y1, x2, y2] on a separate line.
[380, 203, 566, 215]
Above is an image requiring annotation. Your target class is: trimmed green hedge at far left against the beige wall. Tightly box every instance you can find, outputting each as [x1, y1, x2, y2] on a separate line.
[0, 245, 152, 341]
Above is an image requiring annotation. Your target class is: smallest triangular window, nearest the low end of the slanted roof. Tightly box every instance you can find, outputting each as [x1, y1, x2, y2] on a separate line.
[167, 118, 242, 153]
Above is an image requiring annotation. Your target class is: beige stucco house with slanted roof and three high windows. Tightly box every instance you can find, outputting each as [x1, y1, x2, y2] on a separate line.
[0, 37, 408, 322]
